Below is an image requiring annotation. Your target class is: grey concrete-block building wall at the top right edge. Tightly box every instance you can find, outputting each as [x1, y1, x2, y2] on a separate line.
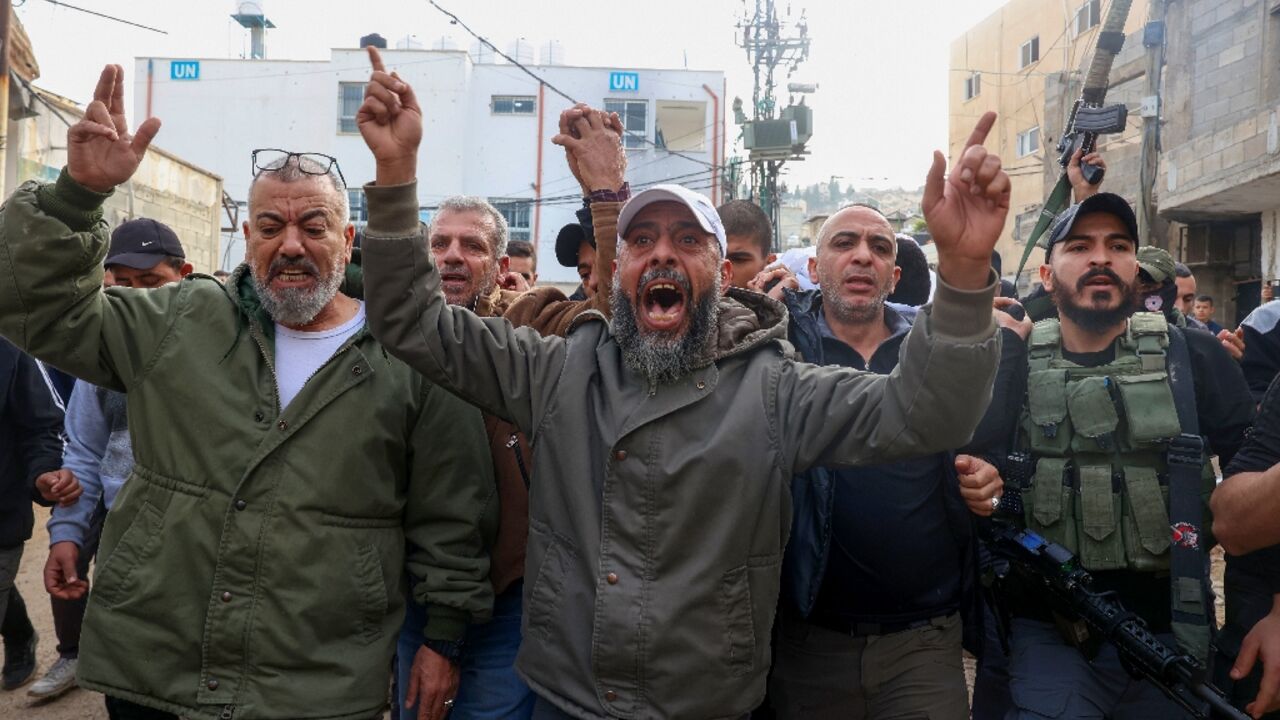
[1156, 0, 1280, 325]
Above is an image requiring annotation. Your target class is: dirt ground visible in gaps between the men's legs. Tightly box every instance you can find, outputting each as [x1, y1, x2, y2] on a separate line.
[0, 507, 1225, 720]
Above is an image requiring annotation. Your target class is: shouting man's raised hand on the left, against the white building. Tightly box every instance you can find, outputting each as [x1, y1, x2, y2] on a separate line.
[356, 46, 422, 184]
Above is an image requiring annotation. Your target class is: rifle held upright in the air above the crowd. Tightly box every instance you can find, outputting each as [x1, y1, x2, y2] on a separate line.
[1018, 0, 1133, 275]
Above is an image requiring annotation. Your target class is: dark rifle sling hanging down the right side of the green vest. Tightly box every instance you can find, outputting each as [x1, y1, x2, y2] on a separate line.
[1167, 325, 1210, 662]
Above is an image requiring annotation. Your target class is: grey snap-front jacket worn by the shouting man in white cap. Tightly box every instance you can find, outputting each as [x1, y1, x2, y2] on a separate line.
[364, 183, 1000, 719]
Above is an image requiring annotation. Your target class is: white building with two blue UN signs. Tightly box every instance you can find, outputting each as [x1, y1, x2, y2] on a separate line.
[133, 44, 726, 283]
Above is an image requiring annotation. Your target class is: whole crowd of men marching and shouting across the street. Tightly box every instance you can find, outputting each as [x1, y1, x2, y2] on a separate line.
[0, 49, 1280, 720]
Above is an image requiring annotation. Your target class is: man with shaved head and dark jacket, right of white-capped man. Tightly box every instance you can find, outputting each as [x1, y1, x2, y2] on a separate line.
[769, 205, 998, 720]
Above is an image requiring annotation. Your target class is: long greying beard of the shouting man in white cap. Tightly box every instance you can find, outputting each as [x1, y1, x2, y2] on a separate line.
[609, 270, 721, 384]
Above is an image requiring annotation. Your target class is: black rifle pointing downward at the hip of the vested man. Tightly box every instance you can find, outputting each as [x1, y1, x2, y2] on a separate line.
[991, 471, 1249, 720]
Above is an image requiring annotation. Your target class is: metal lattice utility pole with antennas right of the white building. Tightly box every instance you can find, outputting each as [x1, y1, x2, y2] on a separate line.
[739, 0, 809, 250]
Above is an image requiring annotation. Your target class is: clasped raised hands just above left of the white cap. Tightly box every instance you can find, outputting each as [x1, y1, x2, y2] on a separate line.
[552, 102, 627, 196]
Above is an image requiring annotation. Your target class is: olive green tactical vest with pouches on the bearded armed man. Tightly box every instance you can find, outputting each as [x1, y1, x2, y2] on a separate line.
[1019, 313, 1215, 657]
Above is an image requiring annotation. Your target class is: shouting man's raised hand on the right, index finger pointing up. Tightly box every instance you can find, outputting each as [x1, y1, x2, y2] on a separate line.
[922, 113, 1010, 290]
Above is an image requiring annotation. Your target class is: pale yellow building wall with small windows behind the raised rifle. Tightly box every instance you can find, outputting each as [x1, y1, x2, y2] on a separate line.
[948, 0, 1147, 275]
